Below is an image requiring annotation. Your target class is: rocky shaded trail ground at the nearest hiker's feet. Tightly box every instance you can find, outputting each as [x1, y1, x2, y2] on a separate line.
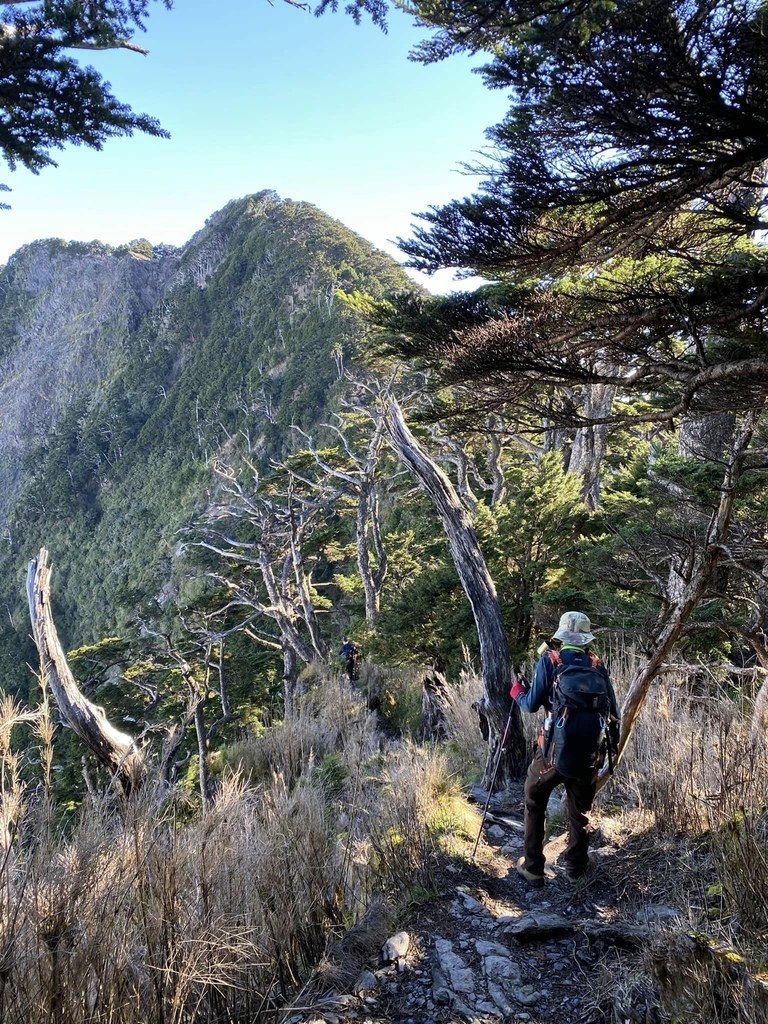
[289, 791, 690, 1024]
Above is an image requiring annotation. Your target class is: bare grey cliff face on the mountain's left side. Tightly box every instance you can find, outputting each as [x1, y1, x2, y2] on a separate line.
[0, 241, 180, 529]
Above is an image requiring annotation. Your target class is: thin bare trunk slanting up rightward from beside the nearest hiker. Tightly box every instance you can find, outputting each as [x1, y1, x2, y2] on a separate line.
[618, 411, 760, 770]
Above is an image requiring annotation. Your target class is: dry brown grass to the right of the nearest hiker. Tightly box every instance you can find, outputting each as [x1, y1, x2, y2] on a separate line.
[607, 652, 768, 1024]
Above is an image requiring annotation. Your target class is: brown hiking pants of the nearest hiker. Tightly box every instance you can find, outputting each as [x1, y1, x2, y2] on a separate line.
[524, 751, 597, 874]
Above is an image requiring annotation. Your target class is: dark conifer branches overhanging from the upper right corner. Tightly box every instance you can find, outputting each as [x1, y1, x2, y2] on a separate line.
[364, 0, 768, 424]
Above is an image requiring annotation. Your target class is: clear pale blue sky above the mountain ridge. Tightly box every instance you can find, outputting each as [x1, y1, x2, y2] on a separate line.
[0, 0, 507, 291]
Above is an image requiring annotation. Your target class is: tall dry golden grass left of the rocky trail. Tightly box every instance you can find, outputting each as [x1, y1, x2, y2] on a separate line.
[0, 683, 450, 1024]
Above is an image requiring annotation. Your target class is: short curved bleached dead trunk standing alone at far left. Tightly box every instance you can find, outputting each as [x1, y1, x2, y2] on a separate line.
[27, 548, 144, 793]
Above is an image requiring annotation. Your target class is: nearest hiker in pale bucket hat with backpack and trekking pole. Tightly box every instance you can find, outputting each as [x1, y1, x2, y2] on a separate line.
[510, 611, 618, 887]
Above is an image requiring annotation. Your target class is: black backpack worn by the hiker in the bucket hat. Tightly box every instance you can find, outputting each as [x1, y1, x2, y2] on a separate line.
[542, 650, 611, 781]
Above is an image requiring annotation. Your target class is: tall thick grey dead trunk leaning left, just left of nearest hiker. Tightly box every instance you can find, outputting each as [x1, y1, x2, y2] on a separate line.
[386, 396, 526, 787]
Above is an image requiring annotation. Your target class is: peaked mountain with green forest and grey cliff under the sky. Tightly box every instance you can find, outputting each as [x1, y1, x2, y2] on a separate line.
[0, 193, 415, 685]
